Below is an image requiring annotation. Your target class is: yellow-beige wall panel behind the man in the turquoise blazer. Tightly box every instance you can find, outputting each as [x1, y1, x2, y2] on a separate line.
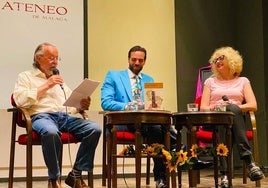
[88, 0, 177, 111]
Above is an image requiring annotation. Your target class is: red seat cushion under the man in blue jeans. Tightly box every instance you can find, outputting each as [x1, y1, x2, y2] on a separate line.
[18, 131, 78, 145]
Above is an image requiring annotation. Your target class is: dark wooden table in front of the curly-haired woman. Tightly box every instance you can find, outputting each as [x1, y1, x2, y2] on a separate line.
[172, 111, 234, 187]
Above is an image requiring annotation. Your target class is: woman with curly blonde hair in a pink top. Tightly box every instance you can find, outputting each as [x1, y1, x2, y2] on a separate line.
[200, 46, 264, 187]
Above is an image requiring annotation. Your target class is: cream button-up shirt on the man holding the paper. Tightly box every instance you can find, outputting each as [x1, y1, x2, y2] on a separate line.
[13, 68, 77, 115]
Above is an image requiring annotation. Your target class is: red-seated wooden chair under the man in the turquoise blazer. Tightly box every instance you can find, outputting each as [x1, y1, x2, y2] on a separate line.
[100, 112, 150, 187]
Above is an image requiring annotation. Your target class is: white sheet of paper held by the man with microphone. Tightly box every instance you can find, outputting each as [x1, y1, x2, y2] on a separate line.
[63, 78, 100, 108]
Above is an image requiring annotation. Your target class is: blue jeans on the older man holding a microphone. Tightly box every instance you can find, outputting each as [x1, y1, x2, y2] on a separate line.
[31, 112, 101, 179]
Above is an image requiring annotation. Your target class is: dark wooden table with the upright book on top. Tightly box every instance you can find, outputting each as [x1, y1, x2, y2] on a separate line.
[105, 110, 171, 188]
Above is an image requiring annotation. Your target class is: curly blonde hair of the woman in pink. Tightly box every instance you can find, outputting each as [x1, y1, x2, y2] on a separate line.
[209, 46, 243, 77]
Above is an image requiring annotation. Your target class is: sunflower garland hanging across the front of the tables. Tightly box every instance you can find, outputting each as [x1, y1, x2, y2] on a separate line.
[143, 143, 229, 171]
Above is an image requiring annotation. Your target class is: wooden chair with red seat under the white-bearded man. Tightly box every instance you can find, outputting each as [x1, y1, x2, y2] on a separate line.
[7, 96, 93, 188]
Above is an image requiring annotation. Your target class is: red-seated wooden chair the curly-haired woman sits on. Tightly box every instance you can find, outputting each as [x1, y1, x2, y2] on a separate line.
[195, 66, 261, 187]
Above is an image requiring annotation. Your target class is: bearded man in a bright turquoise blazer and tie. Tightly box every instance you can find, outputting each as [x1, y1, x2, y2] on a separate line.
[101, 46, 170, 188]
